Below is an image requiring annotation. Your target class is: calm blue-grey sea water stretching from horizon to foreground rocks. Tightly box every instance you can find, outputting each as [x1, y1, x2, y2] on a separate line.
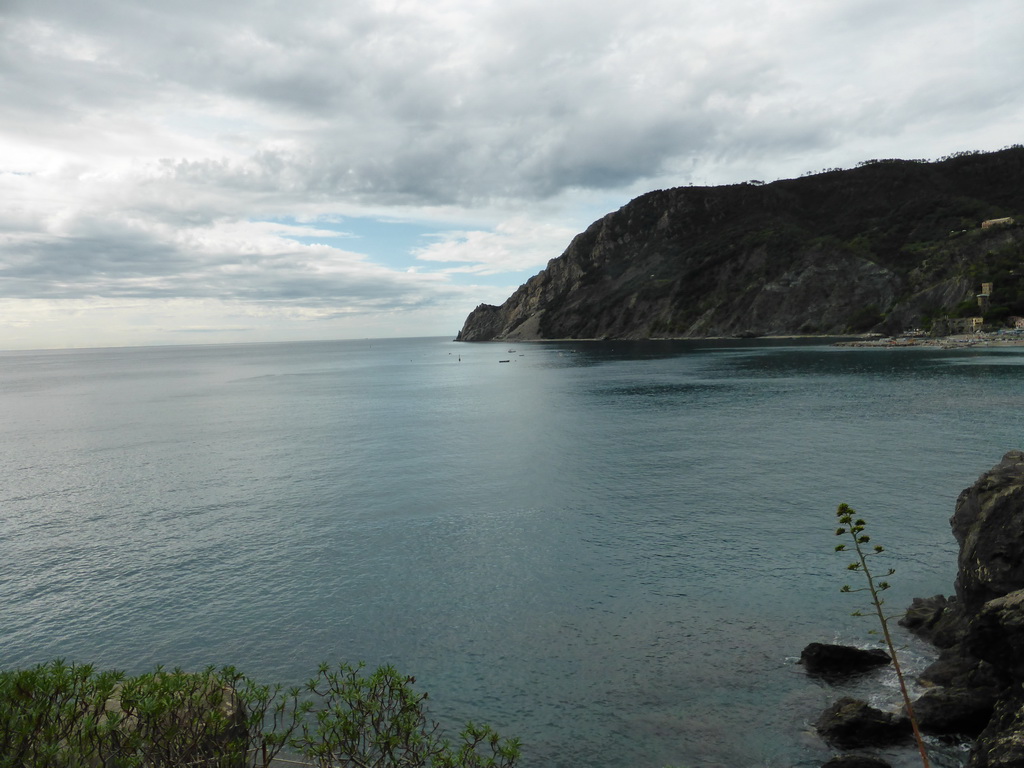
[0, 339, 1024, 768]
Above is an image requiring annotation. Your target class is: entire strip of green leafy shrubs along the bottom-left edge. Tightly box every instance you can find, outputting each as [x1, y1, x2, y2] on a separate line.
[0, 659, 519, 768]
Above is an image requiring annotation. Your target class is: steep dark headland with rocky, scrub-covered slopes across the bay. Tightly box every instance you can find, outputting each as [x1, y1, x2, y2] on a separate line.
[458, 147, 1024, 341]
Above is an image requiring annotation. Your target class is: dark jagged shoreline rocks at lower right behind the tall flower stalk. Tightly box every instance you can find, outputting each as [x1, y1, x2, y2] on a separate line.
[802, 451, 1024, 768]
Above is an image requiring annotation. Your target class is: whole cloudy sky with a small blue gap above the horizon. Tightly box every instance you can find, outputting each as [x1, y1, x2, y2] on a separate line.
[0, 0, 1024, 349]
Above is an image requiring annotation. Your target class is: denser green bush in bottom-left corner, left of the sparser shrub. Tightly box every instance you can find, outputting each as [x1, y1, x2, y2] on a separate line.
[0, 659, 307, 768]
